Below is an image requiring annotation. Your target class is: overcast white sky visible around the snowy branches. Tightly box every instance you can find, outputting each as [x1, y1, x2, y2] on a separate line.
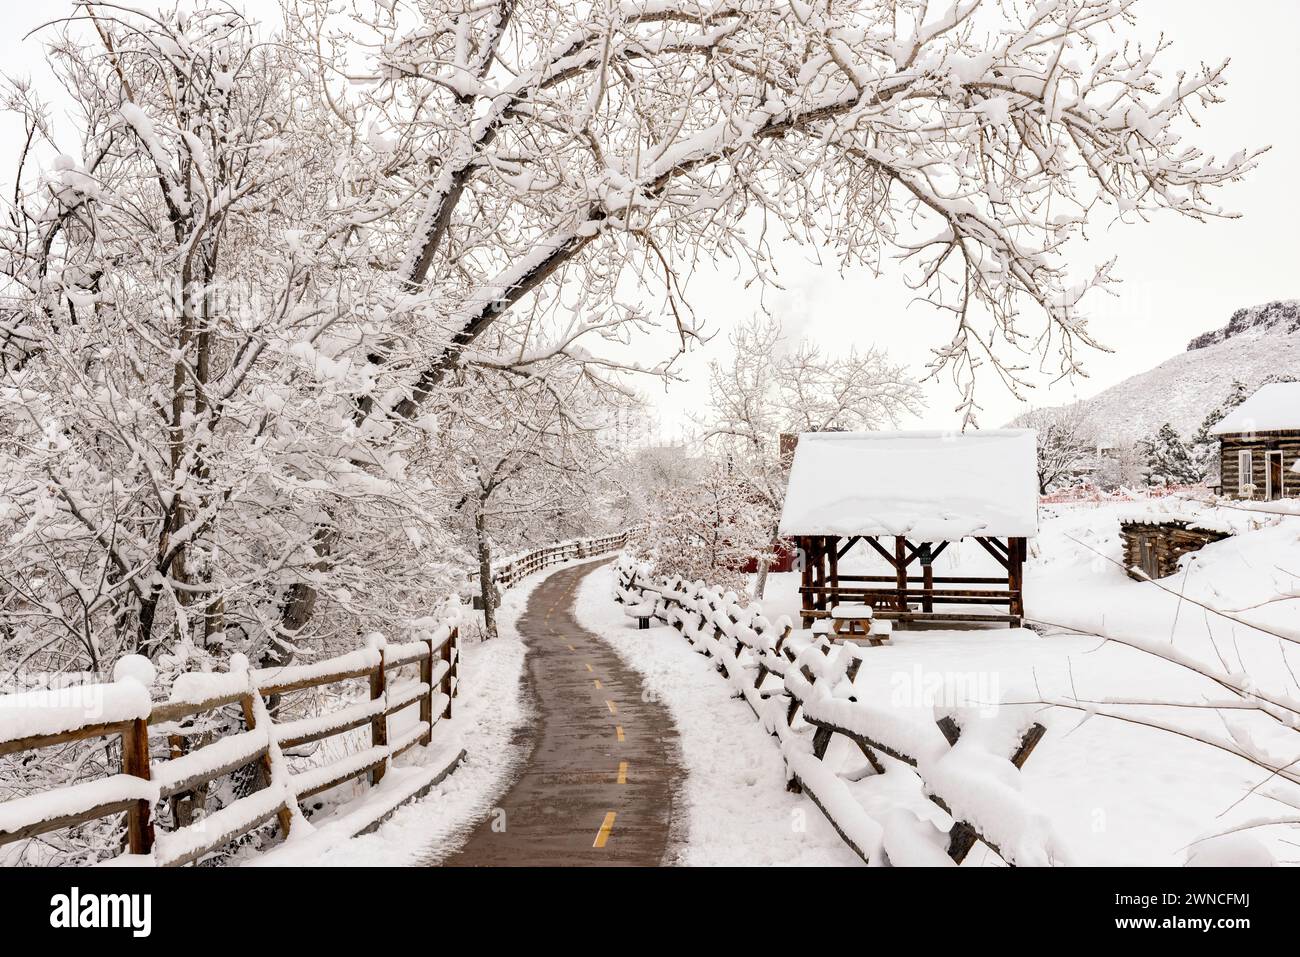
[0, 0, 1300, 436]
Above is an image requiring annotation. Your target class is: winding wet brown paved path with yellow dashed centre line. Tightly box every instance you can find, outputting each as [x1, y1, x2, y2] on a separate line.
[443, 562, 683, 867]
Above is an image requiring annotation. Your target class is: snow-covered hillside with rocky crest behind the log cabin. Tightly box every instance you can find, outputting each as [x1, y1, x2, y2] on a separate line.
[1060, 300, 1300, 445]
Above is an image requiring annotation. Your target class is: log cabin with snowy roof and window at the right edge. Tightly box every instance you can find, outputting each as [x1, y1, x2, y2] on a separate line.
[1210, 382, 1300, 501]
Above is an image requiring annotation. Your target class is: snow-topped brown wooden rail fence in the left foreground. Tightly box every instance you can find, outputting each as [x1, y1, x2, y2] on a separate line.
[0, 621, 464, 866]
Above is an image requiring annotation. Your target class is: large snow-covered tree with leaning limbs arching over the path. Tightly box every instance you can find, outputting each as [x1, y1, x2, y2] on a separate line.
[276, 0, 1256, 634]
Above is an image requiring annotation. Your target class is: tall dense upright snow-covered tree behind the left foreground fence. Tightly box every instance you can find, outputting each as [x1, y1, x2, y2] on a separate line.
[0, 7, 467, 670]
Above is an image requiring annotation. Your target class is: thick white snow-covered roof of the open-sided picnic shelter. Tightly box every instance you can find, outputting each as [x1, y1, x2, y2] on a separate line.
[780, 429, 1039, 542]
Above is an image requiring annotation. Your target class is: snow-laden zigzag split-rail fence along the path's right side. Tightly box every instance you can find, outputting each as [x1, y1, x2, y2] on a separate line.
[614, 557, 1067, 866]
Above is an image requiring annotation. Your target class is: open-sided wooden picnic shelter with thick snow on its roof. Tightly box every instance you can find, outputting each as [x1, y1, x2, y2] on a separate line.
[780, 429, 1037, 628]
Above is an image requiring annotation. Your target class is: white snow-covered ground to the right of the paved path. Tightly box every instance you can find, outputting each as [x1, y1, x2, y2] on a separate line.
[579, 505, 1300, 866]
